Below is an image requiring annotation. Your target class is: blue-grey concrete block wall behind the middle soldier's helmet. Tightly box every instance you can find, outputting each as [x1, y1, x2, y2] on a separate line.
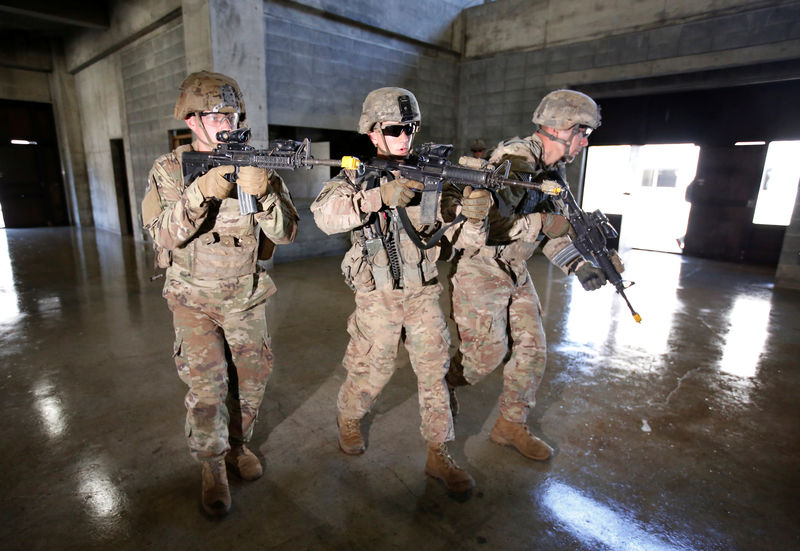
[264, 0, 459, 141]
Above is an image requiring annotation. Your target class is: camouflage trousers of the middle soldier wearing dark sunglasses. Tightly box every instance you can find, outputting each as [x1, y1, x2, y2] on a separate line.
[337, 284, 454, 442]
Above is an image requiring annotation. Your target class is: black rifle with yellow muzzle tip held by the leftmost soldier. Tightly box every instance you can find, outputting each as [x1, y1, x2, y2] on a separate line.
[183, 128, 358, 215]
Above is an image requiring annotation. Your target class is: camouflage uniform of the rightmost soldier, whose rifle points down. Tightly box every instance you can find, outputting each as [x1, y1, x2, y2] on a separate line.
[445, 134, 575, 423]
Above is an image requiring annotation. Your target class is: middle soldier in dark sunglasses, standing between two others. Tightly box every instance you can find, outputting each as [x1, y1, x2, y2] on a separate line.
[311, 88, 491, 492]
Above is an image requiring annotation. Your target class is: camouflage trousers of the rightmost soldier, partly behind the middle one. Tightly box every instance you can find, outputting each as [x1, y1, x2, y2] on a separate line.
[451, 257, 547, 423]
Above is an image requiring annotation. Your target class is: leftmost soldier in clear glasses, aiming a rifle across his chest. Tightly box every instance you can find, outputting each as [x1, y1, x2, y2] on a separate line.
[142, 71, 298, 516]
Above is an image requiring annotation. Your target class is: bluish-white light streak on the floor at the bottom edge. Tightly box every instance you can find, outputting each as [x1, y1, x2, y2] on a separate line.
[539, 481, 693, 551]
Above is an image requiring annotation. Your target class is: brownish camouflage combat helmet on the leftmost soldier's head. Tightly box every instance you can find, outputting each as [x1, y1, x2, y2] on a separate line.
[174, 71, 245, 120]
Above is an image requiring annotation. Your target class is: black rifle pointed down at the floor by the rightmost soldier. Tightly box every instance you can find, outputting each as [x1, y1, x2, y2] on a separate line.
[545, 170, 642, 323]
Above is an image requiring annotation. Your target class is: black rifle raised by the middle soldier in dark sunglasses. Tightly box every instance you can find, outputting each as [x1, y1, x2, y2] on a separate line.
[356, 143, 561, 224]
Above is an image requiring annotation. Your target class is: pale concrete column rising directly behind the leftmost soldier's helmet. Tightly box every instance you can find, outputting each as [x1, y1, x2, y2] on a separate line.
[183, 0, 268, 147]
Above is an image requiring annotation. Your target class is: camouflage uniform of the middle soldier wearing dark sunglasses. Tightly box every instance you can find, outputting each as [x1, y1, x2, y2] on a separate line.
[311, 170, 485, 443]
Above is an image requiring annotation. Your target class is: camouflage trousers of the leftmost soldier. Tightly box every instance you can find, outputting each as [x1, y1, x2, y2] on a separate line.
[169, 300, 273, 460]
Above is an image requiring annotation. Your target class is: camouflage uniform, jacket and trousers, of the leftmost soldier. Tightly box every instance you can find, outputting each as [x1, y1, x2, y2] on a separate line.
[142, 146, 298, 461]
